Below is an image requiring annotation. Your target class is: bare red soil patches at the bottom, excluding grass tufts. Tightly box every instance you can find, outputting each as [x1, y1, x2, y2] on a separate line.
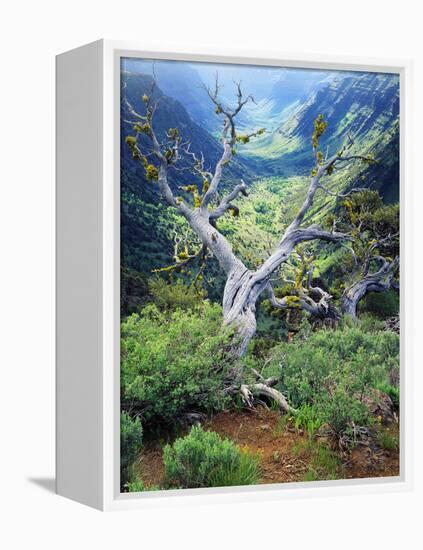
[139, 408, 399, 487]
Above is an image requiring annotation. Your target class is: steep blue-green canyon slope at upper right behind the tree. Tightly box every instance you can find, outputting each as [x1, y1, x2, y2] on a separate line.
[272, 74, 399, 201]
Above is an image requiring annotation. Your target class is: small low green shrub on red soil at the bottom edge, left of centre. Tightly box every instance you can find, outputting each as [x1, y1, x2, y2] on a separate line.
[163, 426, 259, 488]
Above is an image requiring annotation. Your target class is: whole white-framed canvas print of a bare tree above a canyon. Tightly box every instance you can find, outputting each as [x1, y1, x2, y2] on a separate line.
[57, 41, 411, 509]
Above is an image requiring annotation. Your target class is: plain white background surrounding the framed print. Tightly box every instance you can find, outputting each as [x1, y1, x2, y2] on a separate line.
[0, 0, 423, 550]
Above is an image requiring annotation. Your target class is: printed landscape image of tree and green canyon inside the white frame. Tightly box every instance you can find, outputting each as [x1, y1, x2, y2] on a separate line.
[121, 60, 400, 492]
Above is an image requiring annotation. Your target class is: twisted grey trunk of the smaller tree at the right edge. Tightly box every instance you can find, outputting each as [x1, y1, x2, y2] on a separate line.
[341, 257, 399, 318]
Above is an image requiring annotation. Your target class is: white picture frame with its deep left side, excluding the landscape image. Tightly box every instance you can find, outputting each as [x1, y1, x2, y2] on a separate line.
[56, 40, 413, 510]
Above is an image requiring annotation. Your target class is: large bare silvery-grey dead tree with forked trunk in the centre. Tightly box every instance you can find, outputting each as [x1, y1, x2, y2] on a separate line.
[124, 77, 371, 406]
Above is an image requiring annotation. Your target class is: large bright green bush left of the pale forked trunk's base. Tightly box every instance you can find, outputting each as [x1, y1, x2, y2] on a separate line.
[121, 302, 232, 427]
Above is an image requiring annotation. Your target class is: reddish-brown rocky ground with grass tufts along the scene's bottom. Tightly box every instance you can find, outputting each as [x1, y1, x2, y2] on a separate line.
[138, 408, 399, 488]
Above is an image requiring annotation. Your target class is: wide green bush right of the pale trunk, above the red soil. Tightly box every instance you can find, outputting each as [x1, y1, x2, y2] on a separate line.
[263, 324, 399, 435]
